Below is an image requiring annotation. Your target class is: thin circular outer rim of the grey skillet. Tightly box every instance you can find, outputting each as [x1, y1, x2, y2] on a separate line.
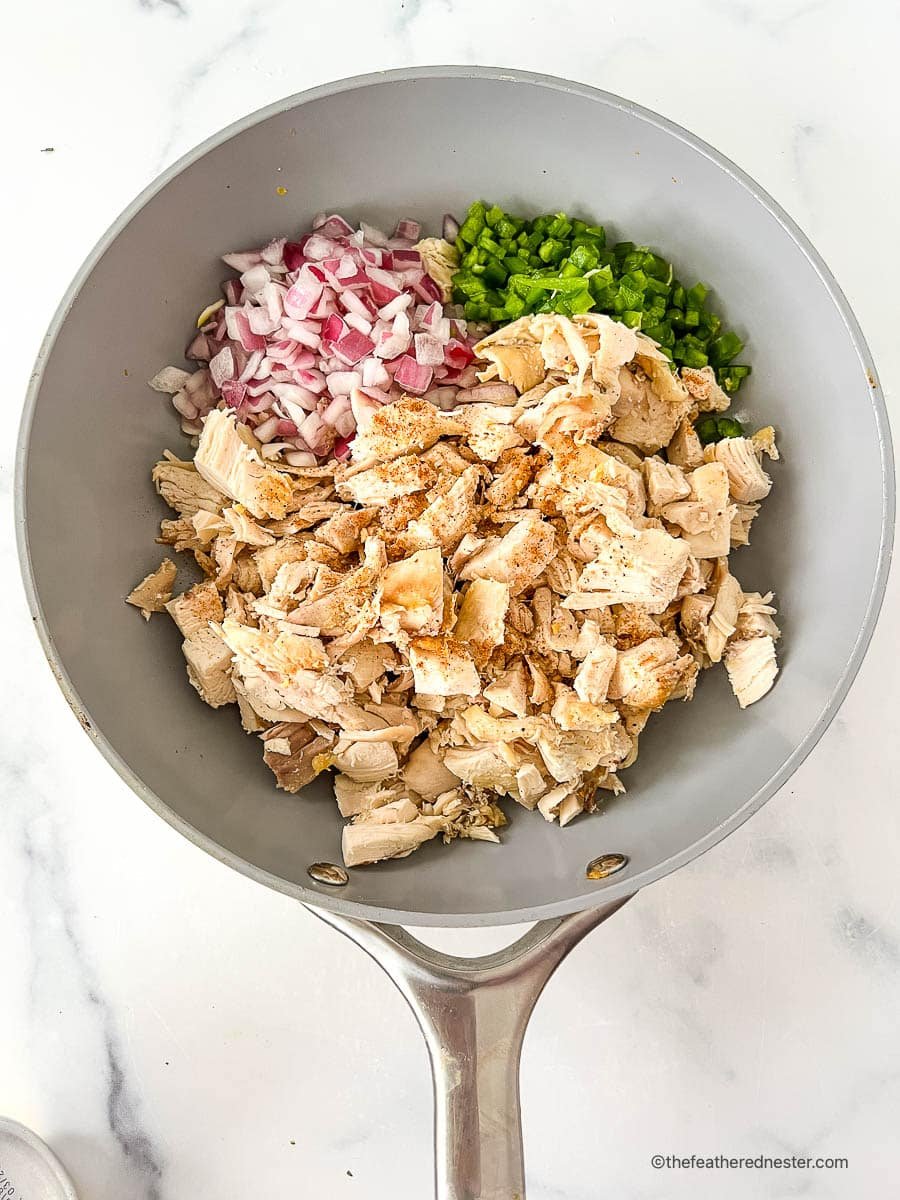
[13, 65, 896, 928]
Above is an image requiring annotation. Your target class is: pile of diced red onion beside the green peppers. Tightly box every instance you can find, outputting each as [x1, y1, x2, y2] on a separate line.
[164, 214, 487, 463]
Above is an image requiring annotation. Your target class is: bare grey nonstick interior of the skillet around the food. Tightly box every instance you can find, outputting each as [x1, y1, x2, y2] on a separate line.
[18, 67, 893, 925]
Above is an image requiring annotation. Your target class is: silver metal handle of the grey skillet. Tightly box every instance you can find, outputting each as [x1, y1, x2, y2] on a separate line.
[310, 898, 630, 1200]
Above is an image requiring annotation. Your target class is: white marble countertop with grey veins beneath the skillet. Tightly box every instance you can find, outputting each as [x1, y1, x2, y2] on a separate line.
[0, 0, 900, 1200]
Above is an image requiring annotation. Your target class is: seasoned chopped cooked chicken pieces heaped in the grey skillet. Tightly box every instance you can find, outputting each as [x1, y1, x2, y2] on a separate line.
[141, 312, 779, 866]
